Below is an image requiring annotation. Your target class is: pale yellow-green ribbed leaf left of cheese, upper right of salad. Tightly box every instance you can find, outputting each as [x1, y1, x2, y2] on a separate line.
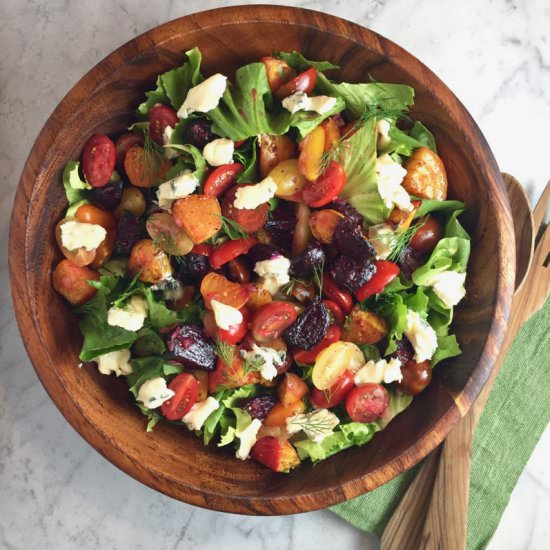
[334, 118, 389, 225]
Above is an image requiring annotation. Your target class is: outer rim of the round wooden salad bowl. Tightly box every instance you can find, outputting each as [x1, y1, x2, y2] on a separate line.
[9, 4, 515, 515]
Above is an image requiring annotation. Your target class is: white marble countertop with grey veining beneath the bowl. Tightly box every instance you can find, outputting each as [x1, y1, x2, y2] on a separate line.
[0, 0, 550, 550]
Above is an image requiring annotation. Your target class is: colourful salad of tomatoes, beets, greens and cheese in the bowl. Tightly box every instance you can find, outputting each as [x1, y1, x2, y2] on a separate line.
[53, 48, 470, 472]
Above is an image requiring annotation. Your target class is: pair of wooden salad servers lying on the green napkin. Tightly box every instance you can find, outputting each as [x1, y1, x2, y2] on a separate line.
[381, 174, 550, 550]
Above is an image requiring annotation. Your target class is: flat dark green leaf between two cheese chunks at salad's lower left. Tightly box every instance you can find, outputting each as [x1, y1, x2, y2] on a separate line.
[76, 275, 138, 361]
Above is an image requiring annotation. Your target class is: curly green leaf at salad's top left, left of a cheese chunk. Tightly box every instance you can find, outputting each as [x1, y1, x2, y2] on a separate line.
[138, 48, 204, 115]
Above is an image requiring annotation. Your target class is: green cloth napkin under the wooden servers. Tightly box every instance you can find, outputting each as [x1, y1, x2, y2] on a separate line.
[331, 299, 550, 549]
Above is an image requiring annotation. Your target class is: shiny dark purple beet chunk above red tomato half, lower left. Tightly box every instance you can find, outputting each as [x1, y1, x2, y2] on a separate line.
[168, 325, 216, 371]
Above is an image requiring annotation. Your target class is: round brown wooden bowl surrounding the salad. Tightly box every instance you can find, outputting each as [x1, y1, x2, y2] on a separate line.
[9, 5, 515, 514]
